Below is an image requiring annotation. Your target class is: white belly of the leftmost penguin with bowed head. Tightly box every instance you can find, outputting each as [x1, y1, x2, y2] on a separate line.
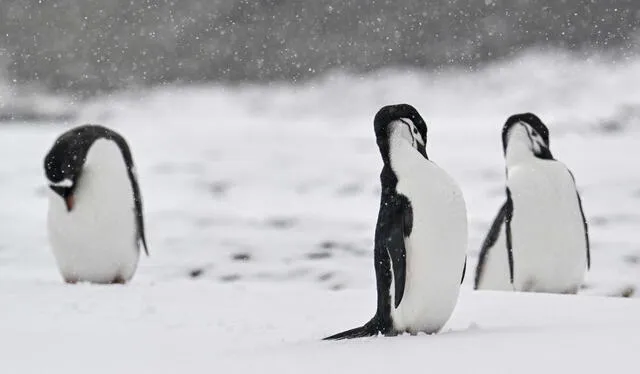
[48, 139, 139, 283]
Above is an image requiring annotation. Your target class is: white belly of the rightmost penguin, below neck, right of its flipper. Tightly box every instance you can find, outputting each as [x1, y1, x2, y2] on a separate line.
[507, 159, 587, 293]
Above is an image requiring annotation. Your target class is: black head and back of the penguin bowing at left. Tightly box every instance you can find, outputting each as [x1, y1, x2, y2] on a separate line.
[44, 125, 149, 255]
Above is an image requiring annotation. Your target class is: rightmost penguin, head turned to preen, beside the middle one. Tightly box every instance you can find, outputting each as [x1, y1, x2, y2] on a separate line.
[474, 113, 591, 294]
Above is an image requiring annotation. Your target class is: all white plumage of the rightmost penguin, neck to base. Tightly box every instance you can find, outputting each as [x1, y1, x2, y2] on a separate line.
[478, 125, 587, 293]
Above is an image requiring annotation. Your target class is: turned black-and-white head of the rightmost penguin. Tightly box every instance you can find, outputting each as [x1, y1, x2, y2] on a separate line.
[502, 113, 553, 159]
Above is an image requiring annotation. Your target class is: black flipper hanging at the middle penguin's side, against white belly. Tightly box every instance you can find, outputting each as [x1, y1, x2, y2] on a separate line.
[381, 194, 413, 308]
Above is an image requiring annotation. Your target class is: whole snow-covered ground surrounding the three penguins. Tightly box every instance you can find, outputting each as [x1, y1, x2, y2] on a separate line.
[0, 51, 640, 373]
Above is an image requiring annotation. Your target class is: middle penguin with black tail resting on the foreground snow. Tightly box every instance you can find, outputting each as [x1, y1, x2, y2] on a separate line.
[324, 104, 467, 340]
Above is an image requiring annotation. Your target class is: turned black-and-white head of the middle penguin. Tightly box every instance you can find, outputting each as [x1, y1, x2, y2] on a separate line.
[373, 104, 428, 162]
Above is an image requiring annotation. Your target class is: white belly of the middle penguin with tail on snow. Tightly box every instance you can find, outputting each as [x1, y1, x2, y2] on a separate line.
[391, 140, 467, 333]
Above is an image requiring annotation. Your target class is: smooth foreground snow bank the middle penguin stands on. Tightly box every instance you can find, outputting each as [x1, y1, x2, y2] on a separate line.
[0, 280, 640, 374]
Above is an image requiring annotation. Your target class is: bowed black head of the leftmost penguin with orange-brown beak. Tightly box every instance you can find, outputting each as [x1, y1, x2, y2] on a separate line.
[44, 125, 121, 212]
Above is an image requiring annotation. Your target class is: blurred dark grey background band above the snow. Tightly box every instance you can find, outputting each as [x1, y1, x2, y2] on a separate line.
[0, 0, 640, 96]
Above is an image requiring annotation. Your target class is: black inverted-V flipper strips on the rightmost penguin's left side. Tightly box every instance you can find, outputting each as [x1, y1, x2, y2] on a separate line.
[476, 193, 513, 289]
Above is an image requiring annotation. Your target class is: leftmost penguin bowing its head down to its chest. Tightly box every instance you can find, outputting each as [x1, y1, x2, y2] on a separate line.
[44, 125, 149, 284]
